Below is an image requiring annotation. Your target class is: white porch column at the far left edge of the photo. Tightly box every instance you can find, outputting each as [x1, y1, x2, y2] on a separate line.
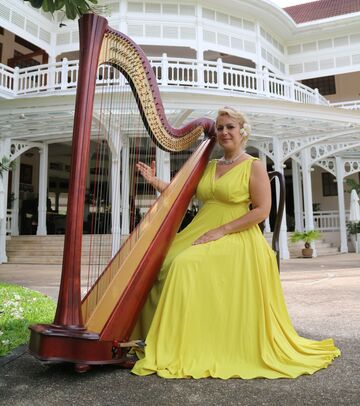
[0, 139, 11, 264]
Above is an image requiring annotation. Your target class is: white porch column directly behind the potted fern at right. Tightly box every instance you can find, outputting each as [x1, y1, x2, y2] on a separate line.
[300, 149, 317, 257]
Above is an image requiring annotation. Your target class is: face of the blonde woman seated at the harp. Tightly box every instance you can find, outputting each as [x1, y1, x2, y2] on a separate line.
[216, 115, 244, 152]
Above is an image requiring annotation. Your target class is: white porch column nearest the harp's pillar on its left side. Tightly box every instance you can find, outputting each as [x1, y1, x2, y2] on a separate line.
[36, 144, 49, 235]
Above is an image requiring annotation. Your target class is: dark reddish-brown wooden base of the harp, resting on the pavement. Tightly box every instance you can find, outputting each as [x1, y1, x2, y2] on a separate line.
[29, 324, 134, 372]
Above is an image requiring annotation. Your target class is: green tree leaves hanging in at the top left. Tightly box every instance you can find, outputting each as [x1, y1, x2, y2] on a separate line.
[24, 0, 97, 20]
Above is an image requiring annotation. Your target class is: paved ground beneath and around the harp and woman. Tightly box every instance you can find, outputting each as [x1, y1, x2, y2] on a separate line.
[0, 254, 360, 406]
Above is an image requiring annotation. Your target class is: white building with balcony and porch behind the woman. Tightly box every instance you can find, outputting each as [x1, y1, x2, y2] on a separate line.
[0, 0, 360, 262]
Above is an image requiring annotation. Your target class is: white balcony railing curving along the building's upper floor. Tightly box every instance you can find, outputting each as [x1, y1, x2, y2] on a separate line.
[0, 54, 329, 105]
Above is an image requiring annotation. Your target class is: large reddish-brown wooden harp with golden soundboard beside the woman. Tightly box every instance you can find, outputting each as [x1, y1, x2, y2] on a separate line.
[29, 15, 215, 371]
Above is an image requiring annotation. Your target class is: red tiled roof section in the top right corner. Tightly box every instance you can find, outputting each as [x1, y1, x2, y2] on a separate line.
[284, 0, 360, 24]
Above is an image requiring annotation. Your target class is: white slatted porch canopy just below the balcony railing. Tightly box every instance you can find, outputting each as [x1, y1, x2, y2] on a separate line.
[0, 90, 360, 159]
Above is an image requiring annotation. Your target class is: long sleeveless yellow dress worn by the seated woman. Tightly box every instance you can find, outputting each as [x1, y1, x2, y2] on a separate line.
[132, 158, 340, 379]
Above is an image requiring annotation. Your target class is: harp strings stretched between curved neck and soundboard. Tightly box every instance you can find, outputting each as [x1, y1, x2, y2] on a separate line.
[82, 31, 210, 323]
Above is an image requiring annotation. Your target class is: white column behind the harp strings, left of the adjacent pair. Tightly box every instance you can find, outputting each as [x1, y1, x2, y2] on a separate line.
[111, 152, 121, 256]
